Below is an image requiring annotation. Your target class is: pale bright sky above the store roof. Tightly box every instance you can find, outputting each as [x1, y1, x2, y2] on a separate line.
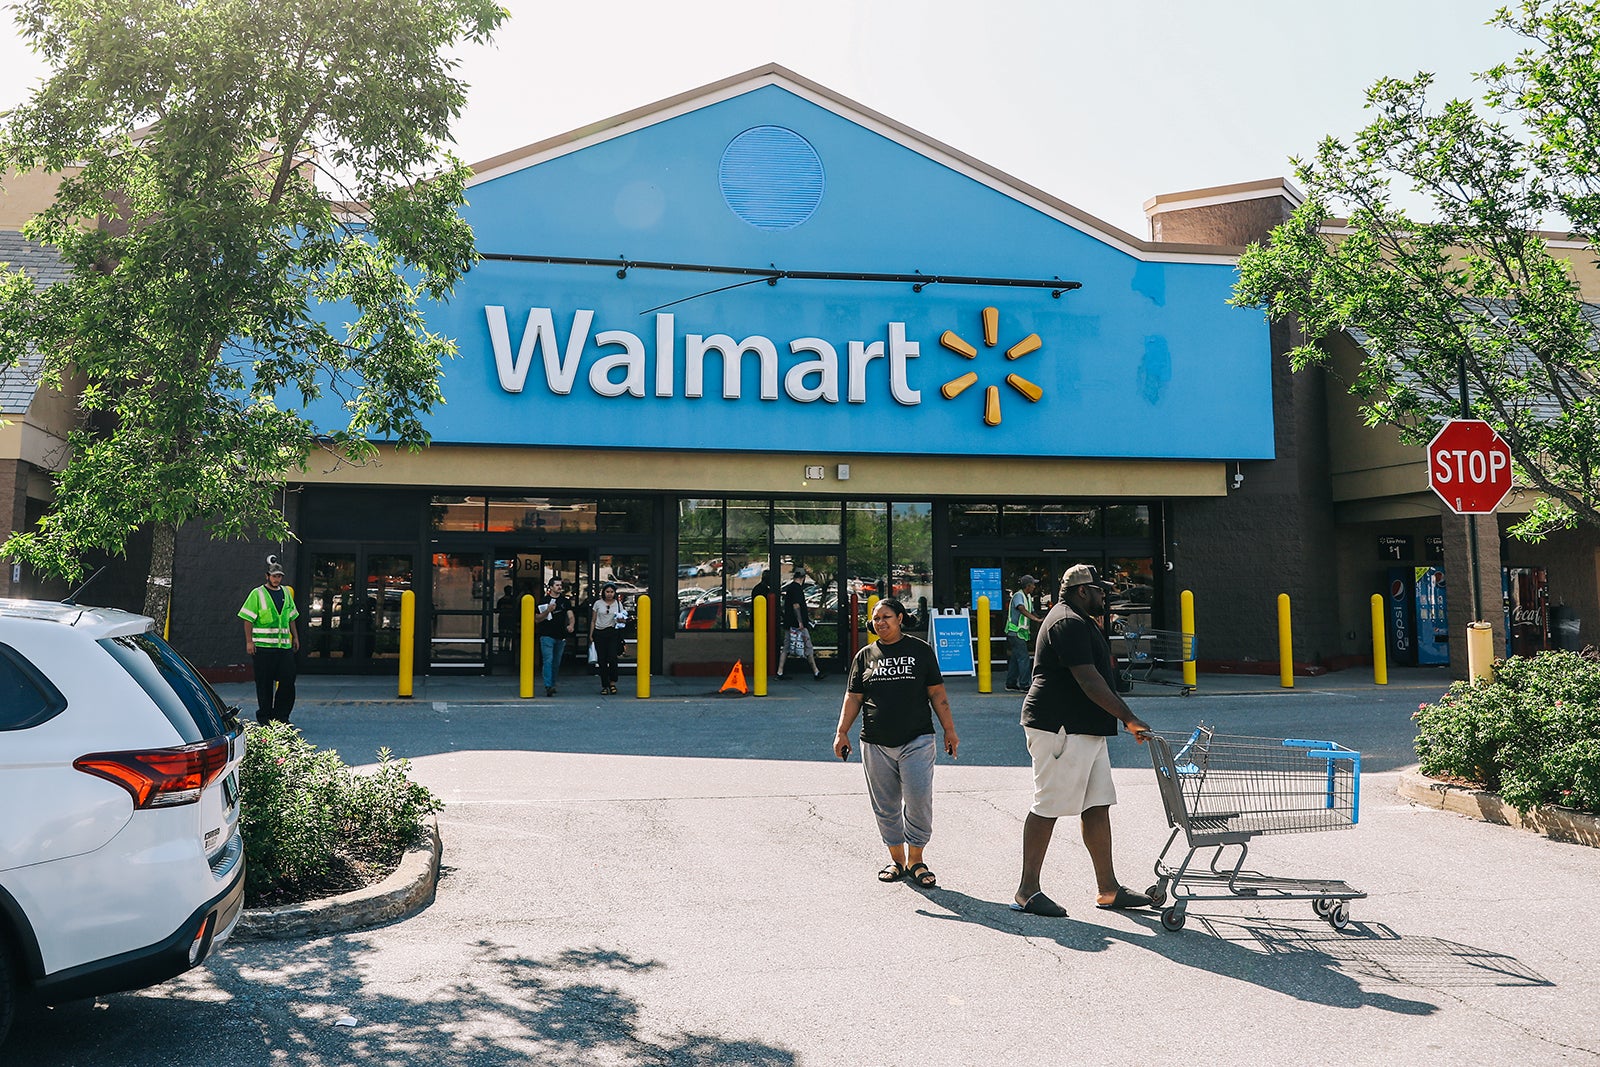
[0, 0, 1522, 237]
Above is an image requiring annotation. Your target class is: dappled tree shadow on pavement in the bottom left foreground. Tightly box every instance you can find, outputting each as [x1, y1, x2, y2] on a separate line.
[5, 936, 795, 1067]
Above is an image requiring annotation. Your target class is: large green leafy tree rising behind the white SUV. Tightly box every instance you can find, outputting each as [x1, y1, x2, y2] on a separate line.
[0, 0, 506, 617]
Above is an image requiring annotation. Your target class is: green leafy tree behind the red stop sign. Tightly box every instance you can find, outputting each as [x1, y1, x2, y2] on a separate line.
[1234, 0, 1600, 539]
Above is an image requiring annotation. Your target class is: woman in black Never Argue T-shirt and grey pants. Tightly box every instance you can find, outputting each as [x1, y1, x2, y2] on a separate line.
[834, 598, 960, 889]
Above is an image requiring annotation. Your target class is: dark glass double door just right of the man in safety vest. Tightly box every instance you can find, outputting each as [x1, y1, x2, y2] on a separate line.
[301, 545, 416, 672]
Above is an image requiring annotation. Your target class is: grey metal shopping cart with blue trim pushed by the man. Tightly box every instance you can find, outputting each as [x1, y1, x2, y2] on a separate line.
[1149, 723, 1366, 929]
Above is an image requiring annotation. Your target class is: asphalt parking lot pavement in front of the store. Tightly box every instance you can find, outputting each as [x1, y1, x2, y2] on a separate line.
[0, 673, 1600, 1067]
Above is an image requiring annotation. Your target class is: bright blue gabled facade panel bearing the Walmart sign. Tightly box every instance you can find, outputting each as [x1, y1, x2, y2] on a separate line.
[308, 86, 1272, 459]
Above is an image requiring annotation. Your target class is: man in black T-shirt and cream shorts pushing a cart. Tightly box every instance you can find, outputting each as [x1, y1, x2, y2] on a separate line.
[1011, 563, 1150, 917]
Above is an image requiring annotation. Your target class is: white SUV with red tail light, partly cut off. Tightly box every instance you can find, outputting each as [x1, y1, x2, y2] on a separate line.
[0, 600, 245, 1045]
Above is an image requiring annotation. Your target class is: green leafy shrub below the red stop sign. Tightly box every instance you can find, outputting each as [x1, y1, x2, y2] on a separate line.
[1414, 649, 1600, 814]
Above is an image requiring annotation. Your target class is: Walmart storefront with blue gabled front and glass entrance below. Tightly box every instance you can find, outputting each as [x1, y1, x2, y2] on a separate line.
[218, 67, 1274, 670]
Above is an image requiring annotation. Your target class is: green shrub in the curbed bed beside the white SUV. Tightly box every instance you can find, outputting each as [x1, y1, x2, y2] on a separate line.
[240, 723, 443, 905]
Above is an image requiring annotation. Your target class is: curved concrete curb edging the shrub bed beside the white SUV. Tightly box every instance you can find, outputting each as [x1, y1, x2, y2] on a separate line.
[234, 819, 443, 941]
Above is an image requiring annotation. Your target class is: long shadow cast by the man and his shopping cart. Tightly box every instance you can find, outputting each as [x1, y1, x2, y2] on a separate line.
[917, 889, 1552, 1016]
